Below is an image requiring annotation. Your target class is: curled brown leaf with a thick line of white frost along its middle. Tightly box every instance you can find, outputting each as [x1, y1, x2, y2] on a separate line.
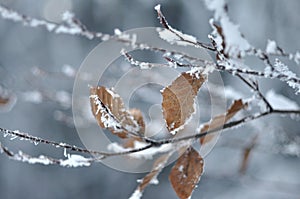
[90, 86, 145, 138]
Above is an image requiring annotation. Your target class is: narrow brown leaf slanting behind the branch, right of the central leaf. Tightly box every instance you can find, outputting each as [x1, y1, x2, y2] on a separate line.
[200, 99, 248, 145]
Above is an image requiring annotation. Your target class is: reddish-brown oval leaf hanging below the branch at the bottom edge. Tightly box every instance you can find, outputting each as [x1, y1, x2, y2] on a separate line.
[169, 148, 204, 199]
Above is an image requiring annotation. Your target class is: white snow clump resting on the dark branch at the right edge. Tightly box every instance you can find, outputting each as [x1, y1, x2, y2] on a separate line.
[266, 90, 299, 110]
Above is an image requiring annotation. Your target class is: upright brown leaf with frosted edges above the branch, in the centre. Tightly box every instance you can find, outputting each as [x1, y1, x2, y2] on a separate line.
[162, 72, 206, 134]
